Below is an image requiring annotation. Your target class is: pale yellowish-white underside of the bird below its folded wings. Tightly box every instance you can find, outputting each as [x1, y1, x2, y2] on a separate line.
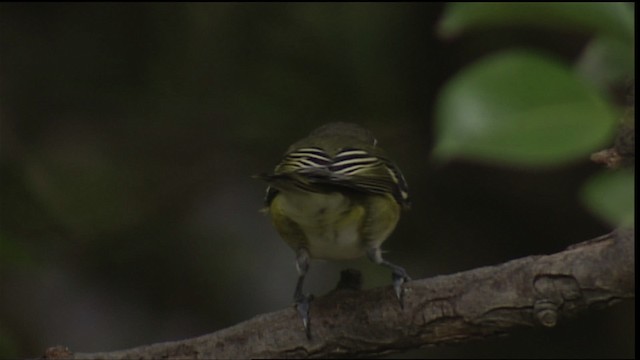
[279, 192, 365, 260]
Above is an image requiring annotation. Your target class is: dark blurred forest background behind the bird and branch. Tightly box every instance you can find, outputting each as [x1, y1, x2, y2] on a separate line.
[0, 3, 635, 358]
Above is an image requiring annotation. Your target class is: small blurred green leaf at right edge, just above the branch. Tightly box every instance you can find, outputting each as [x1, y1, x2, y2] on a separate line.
[582, 169, 635, 227]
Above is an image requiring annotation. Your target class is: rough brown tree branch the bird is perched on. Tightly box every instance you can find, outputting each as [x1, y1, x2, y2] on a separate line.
[45, 230, 635, 359]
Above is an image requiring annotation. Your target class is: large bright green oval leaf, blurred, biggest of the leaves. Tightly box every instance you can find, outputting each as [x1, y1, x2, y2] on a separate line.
[434, 51, 615, 166]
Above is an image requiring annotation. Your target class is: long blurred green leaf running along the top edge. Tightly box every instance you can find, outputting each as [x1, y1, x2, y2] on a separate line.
[438, 2, 635, 44]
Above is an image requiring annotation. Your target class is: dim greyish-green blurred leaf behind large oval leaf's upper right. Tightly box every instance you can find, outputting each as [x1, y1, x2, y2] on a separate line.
[576, 37, 635, 90]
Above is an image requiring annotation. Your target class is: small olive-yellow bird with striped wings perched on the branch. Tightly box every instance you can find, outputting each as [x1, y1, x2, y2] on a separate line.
[257, 122, 410, 338]
